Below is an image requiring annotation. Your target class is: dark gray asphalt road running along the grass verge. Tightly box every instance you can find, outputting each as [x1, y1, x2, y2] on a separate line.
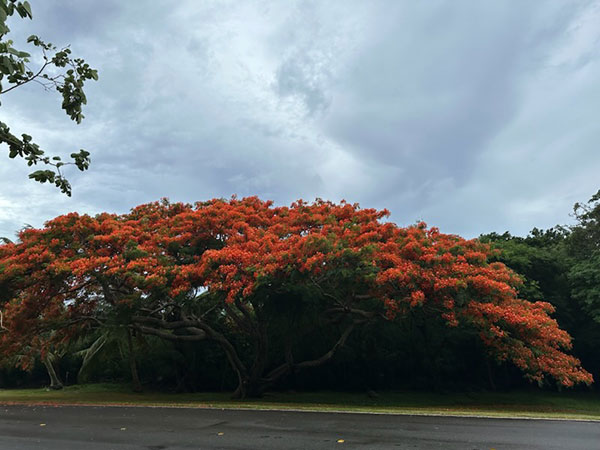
[0, 406, 600, 450]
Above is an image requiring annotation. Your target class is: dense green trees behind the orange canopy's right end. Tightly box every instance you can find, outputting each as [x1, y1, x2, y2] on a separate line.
[480, 191, 600, 384]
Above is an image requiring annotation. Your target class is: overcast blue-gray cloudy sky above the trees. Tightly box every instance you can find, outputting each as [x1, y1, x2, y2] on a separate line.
[0, 0, 600, 237]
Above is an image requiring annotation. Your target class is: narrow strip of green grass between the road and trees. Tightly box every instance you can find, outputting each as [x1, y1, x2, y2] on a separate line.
[0, 384, 600, 420]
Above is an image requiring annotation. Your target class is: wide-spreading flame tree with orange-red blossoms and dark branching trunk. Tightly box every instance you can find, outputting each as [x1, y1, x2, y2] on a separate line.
[0, 197, 592, 397]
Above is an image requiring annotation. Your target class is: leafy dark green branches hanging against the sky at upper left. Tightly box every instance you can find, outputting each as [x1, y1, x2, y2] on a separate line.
[0, 0, 98, 196]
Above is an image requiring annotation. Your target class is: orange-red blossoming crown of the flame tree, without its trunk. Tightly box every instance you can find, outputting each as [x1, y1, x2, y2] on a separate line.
[0, 197, 592, 386]
